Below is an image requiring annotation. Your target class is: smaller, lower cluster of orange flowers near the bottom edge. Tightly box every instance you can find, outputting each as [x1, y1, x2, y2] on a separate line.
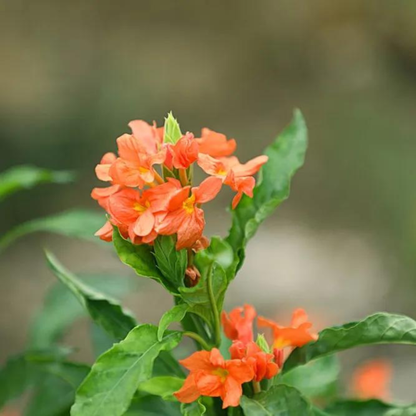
[175, 305, 317, 408]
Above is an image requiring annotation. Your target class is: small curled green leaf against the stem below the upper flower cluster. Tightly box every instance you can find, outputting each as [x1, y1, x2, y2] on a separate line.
[179, 260, 228, 324]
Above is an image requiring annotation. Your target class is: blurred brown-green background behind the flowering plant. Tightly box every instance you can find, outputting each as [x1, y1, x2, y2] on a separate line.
[0, 0, 416, 400]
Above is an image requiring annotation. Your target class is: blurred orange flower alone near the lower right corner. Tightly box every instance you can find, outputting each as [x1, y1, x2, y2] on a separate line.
[352, 359, 392, 400]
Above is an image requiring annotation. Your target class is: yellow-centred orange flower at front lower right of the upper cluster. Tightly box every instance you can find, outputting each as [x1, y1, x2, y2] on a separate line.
[156, 177, 221, 250]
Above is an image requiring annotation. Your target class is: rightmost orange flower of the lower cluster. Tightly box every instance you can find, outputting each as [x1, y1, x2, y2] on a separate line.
[257, 309, 318, 349]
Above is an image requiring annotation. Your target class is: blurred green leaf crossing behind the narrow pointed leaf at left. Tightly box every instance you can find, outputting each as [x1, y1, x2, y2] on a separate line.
[29, 274, 138, 348]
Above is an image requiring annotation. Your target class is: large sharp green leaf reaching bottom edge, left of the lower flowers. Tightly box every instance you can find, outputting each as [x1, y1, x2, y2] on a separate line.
[71, 325, 182, 416]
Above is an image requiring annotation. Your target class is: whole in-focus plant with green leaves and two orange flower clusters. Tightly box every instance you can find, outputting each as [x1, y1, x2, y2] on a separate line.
[0, 111, 416, 416]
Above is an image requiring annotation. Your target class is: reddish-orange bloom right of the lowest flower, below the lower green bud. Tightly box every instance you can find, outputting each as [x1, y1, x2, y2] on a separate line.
[230, 341, 279, 381]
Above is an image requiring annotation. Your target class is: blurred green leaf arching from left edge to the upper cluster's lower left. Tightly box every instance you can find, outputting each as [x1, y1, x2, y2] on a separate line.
[0, 210, 105, 252]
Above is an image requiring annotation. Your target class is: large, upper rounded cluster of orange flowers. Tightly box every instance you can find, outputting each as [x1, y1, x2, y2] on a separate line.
[92, 115, 267, 250]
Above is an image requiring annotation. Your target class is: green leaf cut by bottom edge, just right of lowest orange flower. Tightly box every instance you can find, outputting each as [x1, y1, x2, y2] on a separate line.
[240, 384, 314, 416]
